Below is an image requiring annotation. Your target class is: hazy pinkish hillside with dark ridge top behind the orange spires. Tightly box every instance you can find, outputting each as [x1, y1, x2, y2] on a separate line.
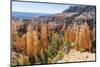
[31, 5, 96, 30]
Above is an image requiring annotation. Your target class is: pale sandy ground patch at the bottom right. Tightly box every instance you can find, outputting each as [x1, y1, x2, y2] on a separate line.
[58, 50, 95, 63]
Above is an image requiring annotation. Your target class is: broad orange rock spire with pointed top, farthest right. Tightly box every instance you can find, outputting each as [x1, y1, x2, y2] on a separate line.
[79, 22, 91, 50]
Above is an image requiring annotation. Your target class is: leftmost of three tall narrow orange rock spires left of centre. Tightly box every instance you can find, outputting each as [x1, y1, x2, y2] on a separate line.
[27, 23, 34, 58]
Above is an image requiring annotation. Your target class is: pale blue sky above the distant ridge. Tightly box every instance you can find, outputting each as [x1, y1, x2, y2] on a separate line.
[12, 1, 70, 14]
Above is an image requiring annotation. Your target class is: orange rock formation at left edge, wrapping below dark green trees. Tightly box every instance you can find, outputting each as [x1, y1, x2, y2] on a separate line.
[12, 21, 27, 54]
